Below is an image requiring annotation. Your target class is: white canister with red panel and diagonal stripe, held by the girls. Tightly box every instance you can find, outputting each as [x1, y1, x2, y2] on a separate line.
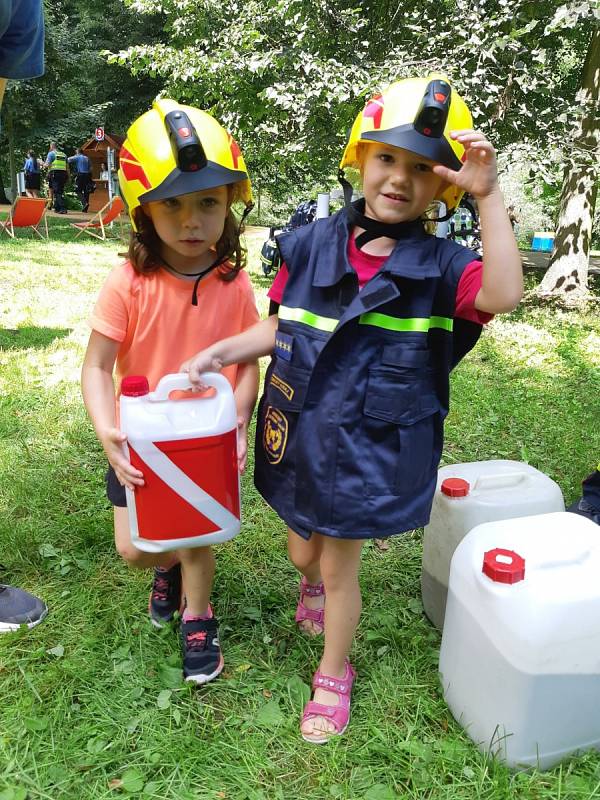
[120, 373, 240, 553]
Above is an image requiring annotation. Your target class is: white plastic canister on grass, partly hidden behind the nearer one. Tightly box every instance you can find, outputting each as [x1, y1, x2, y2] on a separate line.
[421, 460, 565, 631]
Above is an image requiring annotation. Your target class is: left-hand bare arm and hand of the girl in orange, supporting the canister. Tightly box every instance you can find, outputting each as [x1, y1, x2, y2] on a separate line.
[81, 331, 144, 489]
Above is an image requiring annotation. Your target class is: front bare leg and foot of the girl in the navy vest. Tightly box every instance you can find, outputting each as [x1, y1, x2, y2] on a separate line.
[302, 533, 363, 737]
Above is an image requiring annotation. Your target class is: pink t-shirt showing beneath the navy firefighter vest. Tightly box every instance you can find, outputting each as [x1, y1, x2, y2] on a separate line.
[268, 236, 494, 325]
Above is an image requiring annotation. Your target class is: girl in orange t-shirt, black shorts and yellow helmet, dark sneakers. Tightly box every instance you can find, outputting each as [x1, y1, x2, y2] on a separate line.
[82, 100, 258, 683]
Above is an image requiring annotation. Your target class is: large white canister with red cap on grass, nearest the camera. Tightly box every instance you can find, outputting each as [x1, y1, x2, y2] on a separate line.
[440, 512, 600, 769]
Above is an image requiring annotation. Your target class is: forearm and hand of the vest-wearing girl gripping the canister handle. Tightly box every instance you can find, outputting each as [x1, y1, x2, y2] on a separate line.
[179, 314, 277, 391]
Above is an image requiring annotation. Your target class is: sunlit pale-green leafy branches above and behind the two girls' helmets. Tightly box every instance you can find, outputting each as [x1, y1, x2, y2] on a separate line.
[106, 0, 598, 196]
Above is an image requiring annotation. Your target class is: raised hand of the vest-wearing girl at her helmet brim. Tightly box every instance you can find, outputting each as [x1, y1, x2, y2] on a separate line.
[433, 130, 498, 197]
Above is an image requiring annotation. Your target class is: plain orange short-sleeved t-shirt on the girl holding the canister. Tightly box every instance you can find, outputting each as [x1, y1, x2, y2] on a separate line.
[90, 261, 259, 397]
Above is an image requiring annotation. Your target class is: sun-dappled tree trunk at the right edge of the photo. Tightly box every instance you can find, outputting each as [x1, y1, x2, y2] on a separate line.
[537, 30, 600, 301]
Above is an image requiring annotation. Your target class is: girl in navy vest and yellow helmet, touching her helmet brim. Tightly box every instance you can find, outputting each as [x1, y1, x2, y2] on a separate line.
[181, 75, 523, 744]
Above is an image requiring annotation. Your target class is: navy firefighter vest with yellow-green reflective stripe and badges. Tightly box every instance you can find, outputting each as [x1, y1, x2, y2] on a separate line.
[255, 210, 479, 539]
